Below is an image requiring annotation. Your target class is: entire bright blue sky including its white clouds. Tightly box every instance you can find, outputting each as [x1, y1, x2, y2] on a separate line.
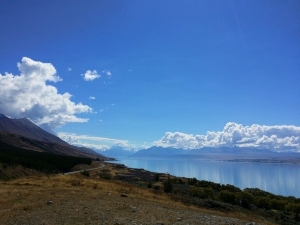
[0, 0, 300, 152]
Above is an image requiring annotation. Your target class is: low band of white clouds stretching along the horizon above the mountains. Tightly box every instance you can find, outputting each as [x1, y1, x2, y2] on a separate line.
[58, 122, 300, 152]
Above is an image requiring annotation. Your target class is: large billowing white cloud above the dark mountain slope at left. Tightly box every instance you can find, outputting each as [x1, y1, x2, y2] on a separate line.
[0, 57, 92, 130]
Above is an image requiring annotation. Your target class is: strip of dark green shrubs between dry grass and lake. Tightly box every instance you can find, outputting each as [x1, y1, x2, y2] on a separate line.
[108, 165, 300, 224]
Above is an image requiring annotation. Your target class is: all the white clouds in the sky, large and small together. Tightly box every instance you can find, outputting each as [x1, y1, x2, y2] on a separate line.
[0, 57, 300, 152]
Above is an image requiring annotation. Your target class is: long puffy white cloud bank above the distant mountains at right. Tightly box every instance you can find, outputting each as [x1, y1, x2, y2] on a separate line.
[154, 122, 300, 151]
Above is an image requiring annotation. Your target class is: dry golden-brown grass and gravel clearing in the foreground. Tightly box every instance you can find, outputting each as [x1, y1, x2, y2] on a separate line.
[0, 171, 276, 224]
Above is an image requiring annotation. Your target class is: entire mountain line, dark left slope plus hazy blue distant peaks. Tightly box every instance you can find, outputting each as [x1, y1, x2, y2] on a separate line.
[0, 114, 300, 160]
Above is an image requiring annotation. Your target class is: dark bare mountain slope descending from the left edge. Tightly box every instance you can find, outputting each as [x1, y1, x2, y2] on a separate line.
[0, 114, 109, 160]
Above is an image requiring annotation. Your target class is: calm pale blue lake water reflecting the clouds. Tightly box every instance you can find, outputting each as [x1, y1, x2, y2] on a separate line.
[111, 158, 300, 198]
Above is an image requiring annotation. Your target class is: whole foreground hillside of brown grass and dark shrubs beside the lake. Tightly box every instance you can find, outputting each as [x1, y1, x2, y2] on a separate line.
[0, 159, 300, 225]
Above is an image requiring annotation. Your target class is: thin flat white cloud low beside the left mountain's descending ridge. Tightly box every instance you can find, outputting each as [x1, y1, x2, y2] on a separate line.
[57, 132, 129, 150]
